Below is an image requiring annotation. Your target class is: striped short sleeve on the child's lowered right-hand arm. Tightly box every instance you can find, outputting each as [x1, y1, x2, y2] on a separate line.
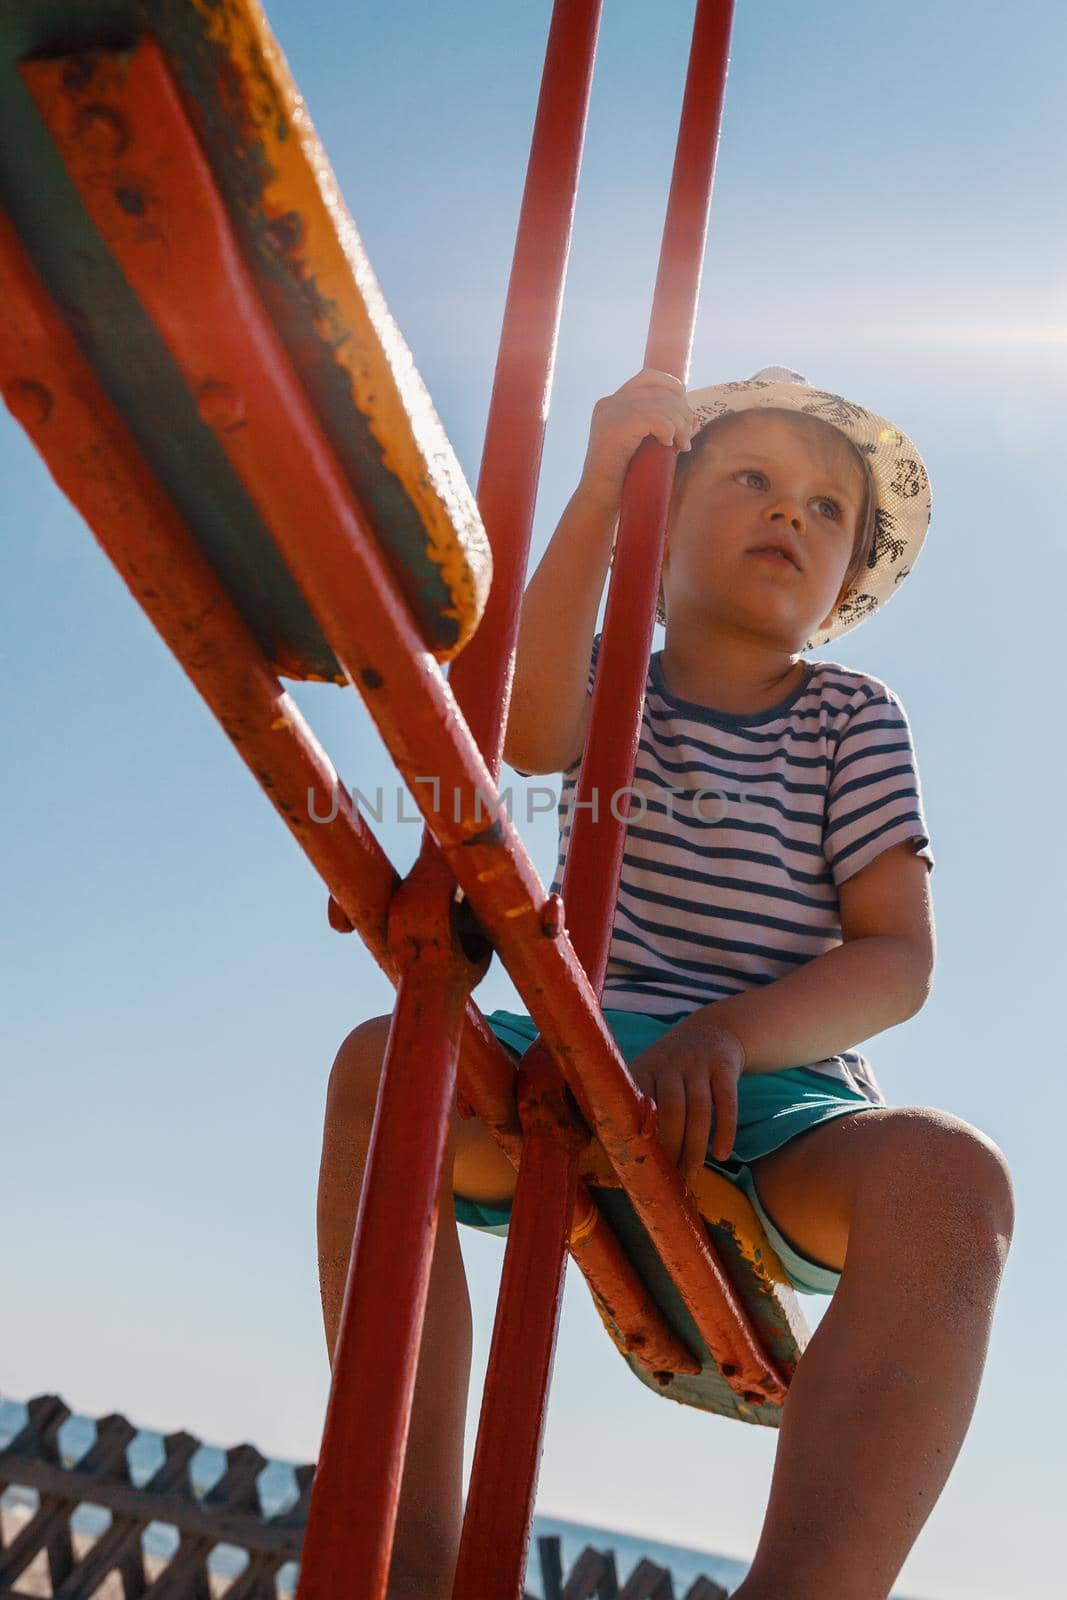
[822, 685, 934, 885]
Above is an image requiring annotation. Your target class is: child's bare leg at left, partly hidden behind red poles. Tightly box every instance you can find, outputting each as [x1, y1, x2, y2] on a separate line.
[318, 1016, 515, 1600]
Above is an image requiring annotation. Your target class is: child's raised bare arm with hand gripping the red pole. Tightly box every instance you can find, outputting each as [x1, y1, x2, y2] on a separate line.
[504, 370, 693, 773]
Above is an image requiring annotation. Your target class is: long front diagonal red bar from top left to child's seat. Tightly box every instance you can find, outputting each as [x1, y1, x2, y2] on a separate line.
[22, 42, 784, 1398]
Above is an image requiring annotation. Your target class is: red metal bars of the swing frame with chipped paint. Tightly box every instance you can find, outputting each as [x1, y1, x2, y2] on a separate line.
[0, 0, 803, 1600]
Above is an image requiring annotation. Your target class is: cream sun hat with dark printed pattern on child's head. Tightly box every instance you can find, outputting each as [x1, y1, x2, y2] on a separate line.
[686, 368, 931, 650]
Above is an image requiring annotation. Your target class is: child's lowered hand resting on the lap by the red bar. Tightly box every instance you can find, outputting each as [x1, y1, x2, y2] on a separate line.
[630, 1013, 745, 1182]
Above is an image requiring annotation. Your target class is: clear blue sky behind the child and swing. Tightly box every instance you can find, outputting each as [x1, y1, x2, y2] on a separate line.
[0, 0, 1067, 1600]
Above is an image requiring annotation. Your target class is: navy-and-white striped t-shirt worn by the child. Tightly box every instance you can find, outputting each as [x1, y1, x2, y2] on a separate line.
[552, 635, 934, 1104]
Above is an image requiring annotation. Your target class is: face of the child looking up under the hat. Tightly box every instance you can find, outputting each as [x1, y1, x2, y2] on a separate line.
[662, 411, 867, 650]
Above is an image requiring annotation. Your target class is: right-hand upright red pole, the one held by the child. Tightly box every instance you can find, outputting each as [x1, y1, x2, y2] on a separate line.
[454, 9, 742, 1600]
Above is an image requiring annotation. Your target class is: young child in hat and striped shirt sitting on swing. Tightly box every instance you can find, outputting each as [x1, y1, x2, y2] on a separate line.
[318, 368, 1013, 1600]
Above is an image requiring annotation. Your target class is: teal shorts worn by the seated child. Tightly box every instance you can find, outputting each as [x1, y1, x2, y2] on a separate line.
[454, 1011, 875, 1294]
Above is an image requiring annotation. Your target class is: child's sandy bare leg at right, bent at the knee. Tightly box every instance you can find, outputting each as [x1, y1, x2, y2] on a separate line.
[736, 1109, 1013, 1600]
